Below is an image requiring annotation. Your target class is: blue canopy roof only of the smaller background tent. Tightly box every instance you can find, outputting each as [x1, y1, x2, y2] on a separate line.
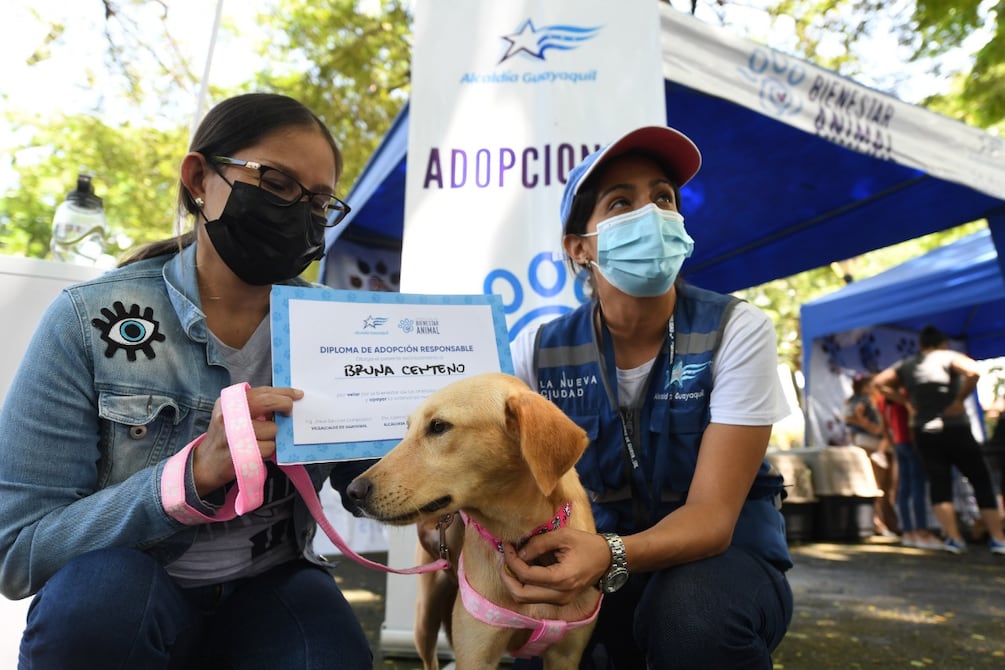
[800, 230, 1005, 370]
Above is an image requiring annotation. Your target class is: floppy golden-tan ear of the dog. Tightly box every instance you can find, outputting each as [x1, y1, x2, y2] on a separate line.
[506, 392, 590, 495]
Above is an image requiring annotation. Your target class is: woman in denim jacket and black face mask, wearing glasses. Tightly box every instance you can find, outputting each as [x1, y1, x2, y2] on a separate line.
[0, 93, 372, 669]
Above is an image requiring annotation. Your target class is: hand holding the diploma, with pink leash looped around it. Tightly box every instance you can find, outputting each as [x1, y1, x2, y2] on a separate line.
[192, 386, 304, 497]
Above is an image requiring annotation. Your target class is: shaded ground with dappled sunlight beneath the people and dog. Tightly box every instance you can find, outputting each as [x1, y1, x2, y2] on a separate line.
[335, 538, 1005, 670]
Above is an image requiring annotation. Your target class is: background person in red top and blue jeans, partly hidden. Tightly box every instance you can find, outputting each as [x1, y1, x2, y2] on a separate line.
[876, 390, 943, 549]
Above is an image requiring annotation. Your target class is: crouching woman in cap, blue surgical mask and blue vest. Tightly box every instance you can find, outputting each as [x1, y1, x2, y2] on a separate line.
[503, 127, 793, 670]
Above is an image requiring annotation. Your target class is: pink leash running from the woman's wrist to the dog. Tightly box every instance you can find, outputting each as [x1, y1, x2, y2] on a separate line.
[161, 383, 453, 575]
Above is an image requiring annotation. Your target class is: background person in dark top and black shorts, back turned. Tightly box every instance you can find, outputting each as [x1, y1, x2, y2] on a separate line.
[874, 325, 1005, 555]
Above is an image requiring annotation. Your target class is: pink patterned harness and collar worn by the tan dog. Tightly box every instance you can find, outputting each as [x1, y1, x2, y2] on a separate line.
[457, 510, 603, 658]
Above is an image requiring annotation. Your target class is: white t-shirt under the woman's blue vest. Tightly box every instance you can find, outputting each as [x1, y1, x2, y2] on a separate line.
[510, 302, 790, 426]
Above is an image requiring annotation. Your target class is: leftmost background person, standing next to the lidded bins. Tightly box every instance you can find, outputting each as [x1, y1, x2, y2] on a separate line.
[844, 373, 897, 537]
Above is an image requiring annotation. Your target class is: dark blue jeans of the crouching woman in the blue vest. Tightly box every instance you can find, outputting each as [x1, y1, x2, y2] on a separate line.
[513, 546, 793, 670]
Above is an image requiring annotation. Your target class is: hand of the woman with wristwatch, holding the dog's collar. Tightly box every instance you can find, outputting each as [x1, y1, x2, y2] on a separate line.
[500, 528, 611, 605]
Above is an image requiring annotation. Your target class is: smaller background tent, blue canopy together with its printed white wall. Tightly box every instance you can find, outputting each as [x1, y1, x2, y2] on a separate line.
[800, 229, 1005, 445]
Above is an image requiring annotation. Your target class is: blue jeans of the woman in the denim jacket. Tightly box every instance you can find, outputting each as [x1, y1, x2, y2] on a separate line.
[18, 548, 373, 670]
